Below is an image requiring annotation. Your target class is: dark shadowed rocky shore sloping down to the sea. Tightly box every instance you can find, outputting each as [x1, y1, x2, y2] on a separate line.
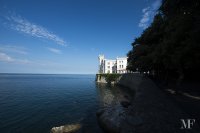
[96, 74, 200, 133]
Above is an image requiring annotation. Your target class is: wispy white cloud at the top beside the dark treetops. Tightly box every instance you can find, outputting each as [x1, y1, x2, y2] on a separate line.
[138, 0, 161, 29]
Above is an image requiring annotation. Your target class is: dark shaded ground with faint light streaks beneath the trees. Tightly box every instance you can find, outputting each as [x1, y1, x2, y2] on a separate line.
[153, 80, 200, 125]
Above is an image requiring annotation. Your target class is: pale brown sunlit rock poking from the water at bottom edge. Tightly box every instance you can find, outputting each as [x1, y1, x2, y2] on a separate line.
[51, 124, 81, 133]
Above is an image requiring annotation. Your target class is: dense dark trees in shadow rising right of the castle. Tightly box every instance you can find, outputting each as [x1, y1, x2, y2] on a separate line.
[127, 0, 200, 82]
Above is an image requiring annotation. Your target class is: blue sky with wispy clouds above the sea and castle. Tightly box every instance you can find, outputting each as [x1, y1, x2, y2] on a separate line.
[0, 0, 161, 74]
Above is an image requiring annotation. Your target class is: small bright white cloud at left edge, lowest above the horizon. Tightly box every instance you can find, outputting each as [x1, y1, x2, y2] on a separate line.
[0, 52, 32, 64]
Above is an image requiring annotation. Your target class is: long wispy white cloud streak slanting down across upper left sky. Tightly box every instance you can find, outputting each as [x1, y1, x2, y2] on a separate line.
[5, 15, 66, 46]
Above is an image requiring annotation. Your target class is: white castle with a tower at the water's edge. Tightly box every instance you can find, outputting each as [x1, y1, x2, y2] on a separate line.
[99, 55, 127, 73]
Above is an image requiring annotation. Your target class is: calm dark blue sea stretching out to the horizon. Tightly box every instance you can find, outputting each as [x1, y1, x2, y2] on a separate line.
[0, 74, 122, 133]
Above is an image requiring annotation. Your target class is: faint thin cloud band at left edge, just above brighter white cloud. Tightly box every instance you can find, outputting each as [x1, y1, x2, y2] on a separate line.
[0, 45, 27, 55]
